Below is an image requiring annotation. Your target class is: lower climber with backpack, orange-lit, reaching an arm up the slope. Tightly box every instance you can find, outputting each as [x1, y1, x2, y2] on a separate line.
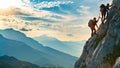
[88, 16, 100, 36]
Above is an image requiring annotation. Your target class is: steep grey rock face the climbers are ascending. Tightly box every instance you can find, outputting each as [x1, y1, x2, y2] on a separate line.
[75, 0, 120, 68]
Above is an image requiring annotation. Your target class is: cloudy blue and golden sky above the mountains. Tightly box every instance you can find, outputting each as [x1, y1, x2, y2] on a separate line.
[0, 0, 112, 41]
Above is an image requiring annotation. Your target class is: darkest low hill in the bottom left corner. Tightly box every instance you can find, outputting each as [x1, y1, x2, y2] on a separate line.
[0, 55, 40, 68]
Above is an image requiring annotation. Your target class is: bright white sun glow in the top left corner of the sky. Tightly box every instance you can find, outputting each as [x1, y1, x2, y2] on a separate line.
[0, 0, 20, 9]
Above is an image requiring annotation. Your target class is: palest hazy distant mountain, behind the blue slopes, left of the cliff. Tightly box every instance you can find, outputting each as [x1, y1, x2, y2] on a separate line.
[34, 35, 85, 57]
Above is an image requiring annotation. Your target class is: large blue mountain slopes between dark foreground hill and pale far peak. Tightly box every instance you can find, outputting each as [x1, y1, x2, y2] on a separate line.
[0, 29, 77, 68]
